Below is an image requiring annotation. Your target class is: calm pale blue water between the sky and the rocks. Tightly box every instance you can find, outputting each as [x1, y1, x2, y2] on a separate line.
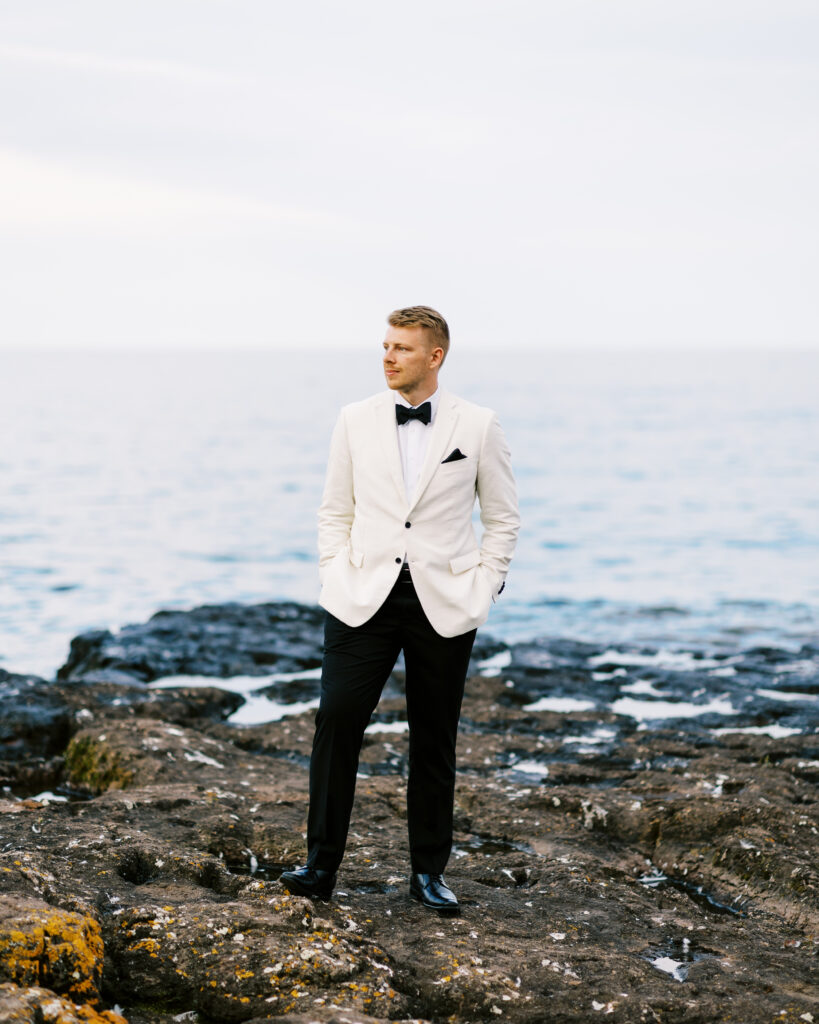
[0, 346, 819, 677]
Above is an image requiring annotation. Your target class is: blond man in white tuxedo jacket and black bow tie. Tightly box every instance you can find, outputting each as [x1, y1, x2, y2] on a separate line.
[281, 306, 520, 913]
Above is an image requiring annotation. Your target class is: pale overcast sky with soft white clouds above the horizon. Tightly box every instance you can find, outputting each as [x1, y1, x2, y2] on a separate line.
[0, 0, 819, 349]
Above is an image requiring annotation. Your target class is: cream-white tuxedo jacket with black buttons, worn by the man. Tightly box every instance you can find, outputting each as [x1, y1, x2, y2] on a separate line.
[318, 389, 520, 637]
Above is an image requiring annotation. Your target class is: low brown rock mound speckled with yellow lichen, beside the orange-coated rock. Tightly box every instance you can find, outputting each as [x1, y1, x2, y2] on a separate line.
[105, 882, 403, 1020]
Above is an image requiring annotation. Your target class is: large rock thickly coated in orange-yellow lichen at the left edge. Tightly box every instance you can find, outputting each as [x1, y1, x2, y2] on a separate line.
[0, 896, 103, 1005]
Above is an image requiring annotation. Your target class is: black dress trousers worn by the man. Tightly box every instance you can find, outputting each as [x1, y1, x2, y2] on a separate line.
[307, 570, 477, 874]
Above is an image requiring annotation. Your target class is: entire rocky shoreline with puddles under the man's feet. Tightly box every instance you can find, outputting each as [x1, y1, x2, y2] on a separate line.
[0, 603, 819, 1024]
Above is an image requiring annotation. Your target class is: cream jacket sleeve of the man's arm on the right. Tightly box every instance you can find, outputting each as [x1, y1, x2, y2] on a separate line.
[477, 413, 520, 600]
